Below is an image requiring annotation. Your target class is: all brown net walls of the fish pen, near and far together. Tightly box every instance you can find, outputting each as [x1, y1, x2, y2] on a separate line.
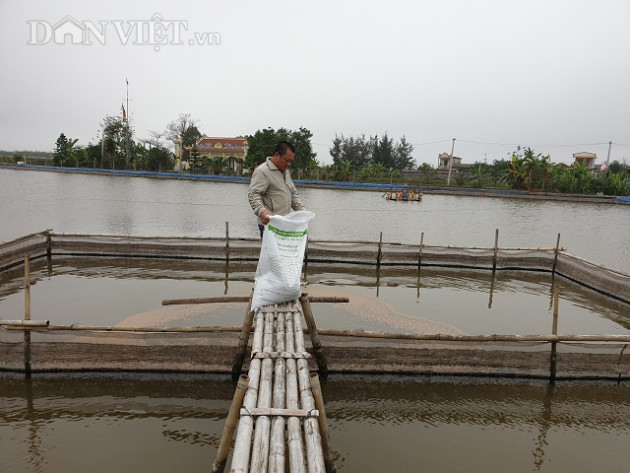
[0, 231, 630, 379]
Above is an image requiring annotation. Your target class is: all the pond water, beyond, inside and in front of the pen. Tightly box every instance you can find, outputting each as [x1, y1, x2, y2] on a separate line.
[0, 168, 630, 473]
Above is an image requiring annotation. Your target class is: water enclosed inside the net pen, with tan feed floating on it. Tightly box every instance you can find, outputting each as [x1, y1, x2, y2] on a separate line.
[0, 258, 630, 335]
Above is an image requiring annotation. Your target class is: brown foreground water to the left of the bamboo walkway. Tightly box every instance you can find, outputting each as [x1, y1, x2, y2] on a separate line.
[0, 375, 232, 472]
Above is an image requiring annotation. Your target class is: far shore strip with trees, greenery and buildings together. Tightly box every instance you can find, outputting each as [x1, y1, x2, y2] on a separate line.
[0, 123, 630, 197]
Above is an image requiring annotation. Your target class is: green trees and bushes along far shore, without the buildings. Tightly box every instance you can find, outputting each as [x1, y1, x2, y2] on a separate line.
[40, 114, 630, 195]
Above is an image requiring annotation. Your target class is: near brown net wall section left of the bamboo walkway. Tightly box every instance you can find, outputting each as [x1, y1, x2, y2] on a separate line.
[0, 326, 240, 373]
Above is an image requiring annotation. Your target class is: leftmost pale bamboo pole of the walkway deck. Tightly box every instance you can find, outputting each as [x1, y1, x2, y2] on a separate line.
[230, 311, 264, 473]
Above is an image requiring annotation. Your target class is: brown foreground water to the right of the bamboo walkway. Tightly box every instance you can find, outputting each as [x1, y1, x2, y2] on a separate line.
[325, 376, 630, 472]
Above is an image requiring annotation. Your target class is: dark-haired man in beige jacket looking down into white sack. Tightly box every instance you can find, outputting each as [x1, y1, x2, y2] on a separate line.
[247, 141, 305, 237]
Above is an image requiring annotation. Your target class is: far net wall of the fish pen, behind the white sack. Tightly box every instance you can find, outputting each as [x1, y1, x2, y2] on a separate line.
[0, 228, 630, 303]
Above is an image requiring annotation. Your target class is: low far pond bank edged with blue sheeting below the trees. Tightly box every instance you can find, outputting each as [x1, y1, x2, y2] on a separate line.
[0, 163, 630, 205]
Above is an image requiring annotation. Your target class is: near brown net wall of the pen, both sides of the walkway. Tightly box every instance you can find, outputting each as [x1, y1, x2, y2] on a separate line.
[0, 326, 630, 380]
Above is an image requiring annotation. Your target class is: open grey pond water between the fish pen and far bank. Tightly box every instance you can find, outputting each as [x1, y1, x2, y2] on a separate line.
[0, 167, 630, 273]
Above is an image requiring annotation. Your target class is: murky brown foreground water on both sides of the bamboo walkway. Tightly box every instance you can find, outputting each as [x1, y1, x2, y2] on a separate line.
[0, 374, 630, 473]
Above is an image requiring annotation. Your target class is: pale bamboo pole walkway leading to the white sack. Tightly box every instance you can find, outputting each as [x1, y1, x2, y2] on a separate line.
[212, 295, 336, 473]
